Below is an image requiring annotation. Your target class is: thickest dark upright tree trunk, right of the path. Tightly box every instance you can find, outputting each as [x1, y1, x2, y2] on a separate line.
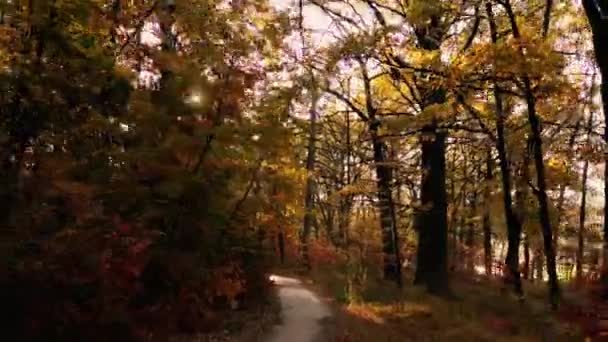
[414, 125, 449, 294]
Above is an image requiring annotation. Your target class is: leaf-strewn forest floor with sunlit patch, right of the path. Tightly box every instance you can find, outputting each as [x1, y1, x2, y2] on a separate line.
[287, 267, 585, 342]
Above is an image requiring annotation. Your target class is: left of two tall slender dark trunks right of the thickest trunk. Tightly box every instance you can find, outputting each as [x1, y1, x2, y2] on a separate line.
[486, 2, 523, 297]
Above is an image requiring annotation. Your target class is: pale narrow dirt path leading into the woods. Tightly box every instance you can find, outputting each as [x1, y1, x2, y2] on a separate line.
[264, 275, 332, 342]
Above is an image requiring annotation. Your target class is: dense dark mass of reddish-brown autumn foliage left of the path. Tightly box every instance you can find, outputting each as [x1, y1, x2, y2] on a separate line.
[0, 0, 298, 341]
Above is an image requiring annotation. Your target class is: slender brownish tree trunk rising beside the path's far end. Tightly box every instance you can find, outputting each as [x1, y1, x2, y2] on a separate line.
[300, 84, 318, 269]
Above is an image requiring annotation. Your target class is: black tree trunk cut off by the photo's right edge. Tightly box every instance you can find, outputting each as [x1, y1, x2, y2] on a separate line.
[583, 0, 608, 296]
